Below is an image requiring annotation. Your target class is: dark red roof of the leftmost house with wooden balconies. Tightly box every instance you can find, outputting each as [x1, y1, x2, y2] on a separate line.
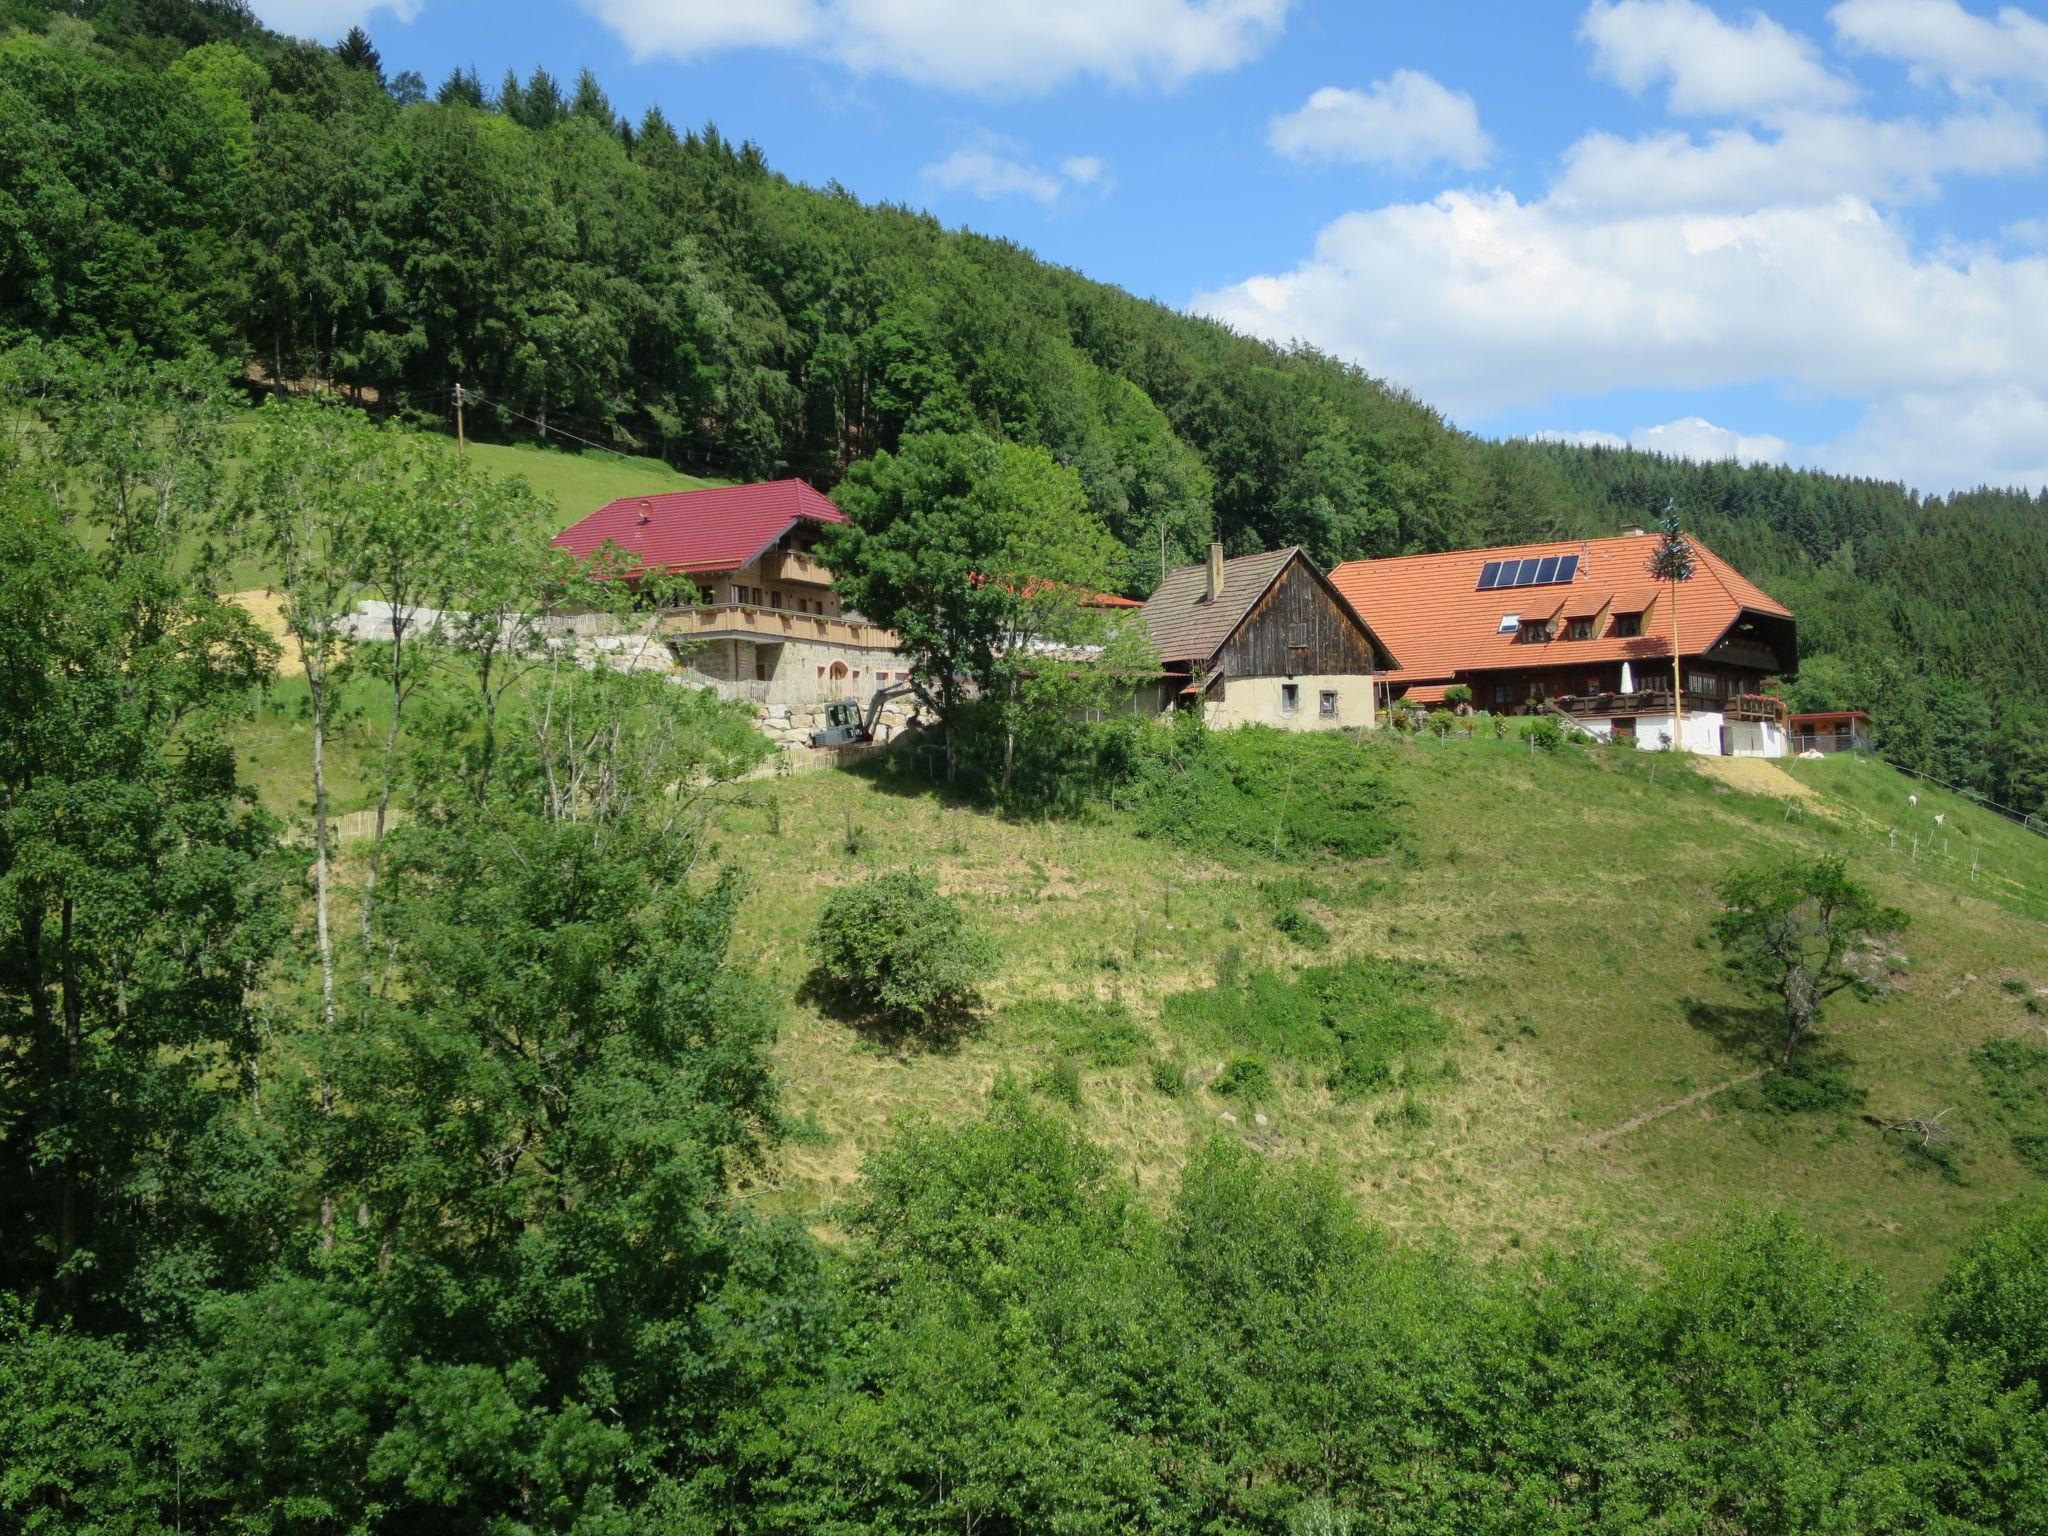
[553, 479, 846, 573]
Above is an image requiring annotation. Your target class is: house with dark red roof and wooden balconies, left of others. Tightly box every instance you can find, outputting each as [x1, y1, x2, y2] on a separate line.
[553, 479, 903, 707]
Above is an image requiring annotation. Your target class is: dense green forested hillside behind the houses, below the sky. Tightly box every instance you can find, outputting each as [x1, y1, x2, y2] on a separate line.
[0, 0, 2048, 809]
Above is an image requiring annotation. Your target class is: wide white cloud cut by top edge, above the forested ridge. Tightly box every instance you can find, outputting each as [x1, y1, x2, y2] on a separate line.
[584, 0, 1290, 96]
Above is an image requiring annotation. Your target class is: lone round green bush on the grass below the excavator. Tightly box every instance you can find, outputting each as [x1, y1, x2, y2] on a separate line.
[813, 870, 995, 1032]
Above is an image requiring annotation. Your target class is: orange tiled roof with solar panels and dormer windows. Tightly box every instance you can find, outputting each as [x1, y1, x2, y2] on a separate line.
[1329, 535, 1792, 684]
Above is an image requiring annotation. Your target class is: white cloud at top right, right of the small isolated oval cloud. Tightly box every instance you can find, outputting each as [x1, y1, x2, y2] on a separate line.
[1579, 0, 1855, 117]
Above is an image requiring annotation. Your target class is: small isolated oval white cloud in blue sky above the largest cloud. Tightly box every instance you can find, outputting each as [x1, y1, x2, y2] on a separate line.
[1268, 70, 1493, 172]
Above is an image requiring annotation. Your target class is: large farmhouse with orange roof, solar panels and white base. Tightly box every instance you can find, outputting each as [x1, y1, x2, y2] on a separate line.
[1331, 532, 1798, 758]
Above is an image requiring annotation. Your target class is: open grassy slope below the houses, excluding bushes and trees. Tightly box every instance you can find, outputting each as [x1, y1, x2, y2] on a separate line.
[708, 741, 2048, 1294]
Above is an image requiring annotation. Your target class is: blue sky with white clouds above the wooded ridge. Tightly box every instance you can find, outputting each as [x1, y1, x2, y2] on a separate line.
[254, 0, 2048, 489]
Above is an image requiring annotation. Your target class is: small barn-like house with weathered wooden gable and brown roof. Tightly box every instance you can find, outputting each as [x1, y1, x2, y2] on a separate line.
[1139, 545, 1397, 731]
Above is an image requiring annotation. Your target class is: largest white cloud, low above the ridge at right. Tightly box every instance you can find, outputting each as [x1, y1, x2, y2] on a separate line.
[1194, 193, 2048, 483]
